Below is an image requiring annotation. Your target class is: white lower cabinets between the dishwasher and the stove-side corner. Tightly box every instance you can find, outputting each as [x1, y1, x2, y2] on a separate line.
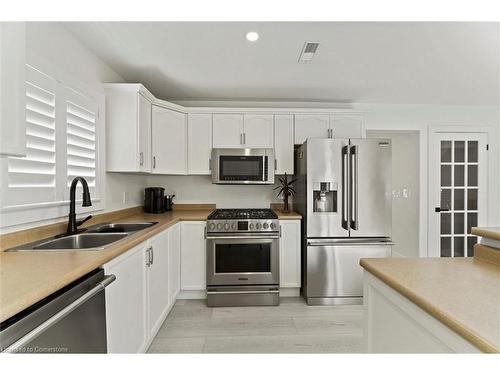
[103, 224, 181, 353]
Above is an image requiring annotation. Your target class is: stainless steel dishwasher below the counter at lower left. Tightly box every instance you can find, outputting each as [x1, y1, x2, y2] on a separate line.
[0, 269, 115, 353]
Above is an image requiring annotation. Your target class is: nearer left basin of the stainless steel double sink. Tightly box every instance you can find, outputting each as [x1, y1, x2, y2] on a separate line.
[6, 233, 128, 251]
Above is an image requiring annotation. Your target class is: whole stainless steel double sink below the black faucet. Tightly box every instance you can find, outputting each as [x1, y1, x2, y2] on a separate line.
[6, 222, 157, 251]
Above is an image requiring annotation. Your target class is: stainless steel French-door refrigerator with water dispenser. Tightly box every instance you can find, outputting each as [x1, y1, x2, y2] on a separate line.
[294, 138, 392, 305]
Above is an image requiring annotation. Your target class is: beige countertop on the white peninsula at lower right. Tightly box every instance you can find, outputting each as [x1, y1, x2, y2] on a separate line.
[360, 258, 500, 353]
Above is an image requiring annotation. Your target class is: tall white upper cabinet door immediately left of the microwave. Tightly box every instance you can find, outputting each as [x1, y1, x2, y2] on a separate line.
[188, 113, 212, 175]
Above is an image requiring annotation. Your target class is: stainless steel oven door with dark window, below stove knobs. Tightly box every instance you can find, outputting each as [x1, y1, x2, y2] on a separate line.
[207, 235, 279, 286]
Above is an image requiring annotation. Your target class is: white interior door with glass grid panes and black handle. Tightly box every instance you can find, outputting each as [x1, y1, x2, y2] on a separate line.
[429, 133, 488, 257]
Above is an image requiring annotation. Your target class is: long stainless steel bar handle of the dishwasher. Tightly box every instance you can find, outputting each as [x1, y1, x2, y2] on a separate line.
[5, 275, 116, 353]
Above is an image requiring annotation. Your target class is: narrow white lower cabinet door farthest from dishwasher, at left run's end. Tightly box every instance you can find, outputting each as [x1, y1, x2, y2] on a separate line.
[168, 224, 181, 306]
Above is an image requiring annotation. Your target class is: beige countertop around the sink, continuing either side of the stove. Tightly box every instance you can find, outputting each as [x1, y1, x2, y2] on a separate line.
[0, 205, 301, 321]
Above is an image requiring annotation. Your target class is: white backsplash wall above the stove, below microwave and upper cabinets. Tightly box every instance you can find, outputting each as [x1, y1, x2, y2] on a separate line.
[148, 176, 281, 208]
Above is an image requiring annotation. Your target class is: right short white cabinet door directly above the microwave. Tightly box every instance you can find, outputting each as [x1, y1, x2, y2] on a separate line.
[243, 114, 274, 148]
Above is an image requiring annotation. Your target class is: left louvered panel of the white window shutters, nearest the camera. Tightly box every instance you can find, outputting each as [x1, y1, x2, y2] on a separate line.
[2, 65, 56, 207]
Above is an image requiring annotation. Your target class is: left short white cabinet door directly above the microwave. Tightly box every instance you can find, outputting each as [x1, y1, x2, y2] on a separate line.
[213, 113, 243, 148]
